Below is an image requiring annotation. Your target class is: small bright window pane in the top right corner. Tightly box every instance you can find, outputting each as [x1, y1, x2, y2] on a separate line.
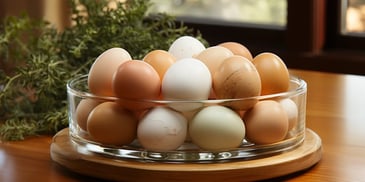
[341, 0, 365, 34]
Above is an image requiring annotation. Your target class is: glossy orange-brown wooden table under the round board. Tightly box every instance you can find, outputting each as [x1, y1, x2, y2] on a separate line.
[0, 70, 365, 181]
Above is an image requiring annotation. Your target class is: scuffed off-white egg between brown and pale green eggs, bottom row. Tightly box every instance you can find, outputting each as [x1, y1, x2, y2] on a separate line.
[137, 107, 187, 151]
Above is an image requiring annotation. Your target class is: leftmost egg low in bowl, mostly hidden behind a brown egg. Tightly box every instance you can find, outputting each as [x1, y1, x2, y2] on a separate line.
[75, 99, 101, 131]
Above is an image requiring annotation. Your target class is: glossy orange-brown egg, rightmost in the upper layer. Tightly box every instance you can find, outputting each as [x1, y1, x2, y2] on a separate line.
[252, 52, 290, 95]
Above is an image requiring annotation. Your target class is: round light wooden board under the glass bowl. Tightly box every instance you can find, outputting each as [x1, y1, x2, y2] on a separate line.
[50, 129, 322, 182]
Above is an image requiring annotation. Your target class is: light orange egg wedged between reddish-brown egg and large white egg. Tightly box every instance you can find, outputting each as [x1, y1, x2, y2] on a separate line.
[143, 50, 176, 80]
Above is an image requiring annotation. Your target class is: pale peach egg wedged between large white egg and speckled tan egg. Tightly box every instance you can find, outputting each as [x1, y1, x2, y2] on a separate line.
[195, 46, 233, 78]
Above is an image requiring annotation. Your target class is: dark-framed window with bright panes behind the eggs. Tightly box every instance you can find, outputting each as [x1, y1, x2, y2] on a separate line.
[149, 0, 365, 75]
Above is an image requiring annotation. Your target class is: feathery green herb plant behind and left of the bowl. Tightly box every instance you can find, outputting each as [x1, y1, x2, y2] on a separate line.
[0, 0, 206, 141]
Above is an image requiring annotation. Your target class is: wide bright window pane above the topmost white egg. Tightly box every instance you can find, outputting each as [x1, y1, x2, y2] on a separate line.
[151, 0, 287, 26]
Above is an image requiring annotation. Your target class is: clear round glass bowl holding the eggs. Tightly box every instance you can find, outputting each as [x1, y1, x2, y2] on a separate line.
[67, 75, 307, 162]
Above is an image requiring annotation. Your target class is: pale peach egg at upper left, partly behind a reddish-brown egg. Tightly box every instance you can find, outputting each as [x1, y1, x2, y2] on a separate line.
[88, 47, 132, 96]
